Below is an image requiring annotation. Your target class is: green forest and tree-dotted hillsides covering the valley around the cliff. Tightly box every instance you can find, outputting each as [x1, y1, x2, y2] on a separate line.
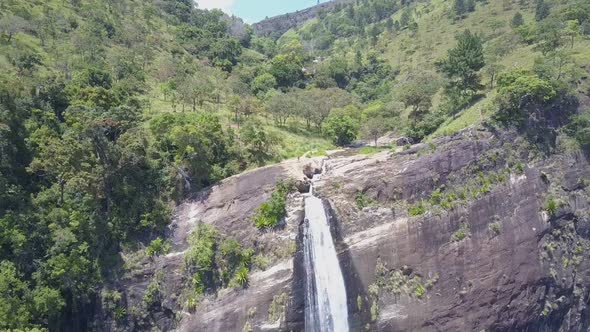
[0, 0, 590, 331]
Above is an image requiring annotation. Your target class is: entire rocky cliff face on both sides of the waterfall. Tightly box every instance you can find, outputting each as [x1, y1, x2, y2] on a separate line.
[106, 129, 590, 331]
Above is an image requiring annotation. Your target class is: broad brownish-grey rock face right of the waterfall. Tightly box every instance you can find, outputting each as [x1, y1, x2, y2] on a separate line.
[318, 131, 590, 331]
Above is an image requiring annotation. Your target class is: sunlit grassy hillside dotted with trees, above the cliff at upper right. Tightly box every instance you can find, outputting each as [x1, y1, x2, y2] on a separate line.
[279, 0, 590, 139]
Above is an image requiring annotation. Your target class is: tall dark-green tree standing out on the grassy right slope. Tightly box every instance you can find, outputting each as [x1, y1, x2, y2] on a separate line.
[436, 30, 485, 106]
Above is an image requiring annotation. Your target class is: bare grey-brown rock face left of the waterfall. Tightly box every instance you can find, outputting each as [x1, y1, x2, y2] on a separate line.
[111, 158, 321, 331]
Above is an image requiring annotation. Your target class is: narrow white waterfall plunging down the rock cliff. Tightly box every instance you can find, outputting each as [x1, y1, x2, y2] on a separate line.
[303, 166, 349, 332]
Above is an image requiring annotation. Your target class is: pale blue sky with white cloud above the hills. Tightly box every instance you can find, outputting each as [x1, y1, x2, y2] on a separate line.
[196, 0, 326, 23]
